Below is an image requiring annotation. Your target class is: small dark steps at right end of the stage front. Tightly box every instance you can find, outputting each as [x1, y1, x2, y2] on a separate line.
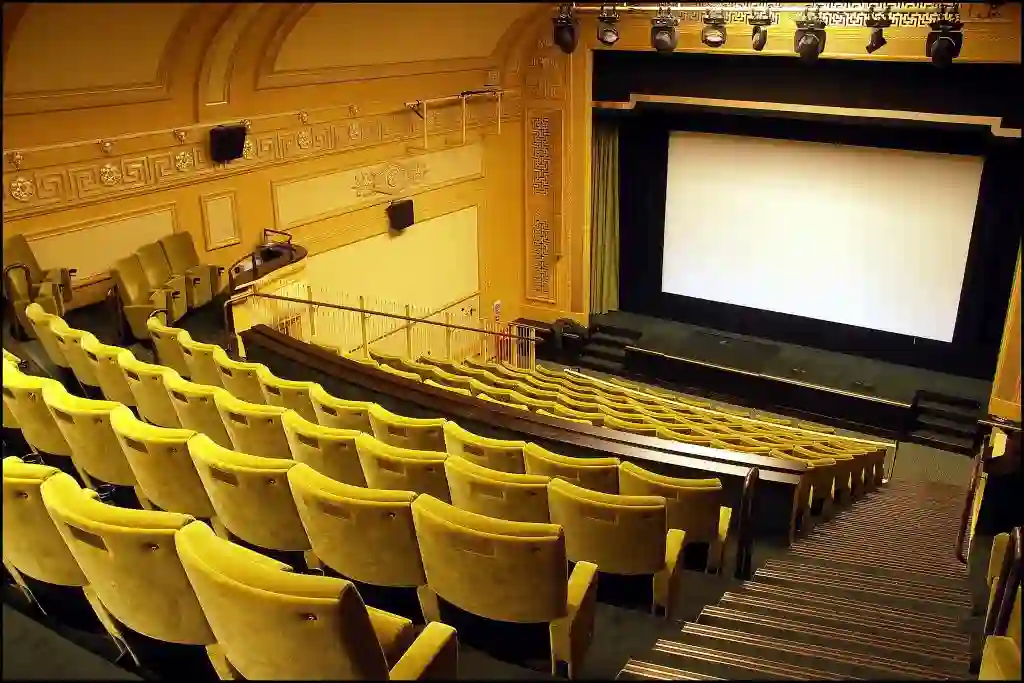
[906, 391, 984, 456]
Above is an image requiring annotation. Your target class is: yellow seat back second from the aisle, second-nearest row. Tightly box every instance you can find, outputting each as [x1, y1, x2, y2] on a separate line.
[288, 464, 427, 587]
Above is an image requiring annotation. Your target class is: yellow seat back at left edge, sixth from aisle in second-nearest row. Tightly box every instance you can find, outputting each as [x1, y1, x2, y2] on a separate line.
[3, 358, 71, 456]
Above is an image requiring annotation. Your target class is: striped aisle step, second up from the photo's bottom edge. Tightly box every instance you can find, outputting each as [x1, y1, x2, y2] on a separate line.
[627, 638, 850, 681]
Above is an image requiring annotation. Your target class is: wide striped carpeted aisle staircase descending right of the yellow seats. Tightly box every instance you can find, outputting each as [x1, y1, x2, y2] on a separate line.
[618, 481, 973, 680]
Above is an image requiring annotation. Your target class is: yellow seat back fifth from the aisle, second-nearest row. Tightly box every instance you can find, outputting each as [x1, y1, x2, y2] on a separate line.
[43, 384, 135, 486]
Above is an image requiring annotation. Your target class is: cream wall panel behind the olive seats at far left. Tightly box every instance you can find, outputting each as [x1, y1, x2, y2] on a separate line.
[27, 204, 177, 282]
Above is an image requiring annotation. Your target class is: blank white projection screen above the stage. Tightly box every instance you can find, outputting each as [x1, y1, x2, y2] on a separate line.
[662, 132, 984, 342]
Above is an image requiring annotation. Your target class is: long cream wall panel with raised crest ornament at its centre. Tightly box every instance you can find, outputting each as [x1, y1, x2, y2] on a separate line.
[273, 144, 483, 229]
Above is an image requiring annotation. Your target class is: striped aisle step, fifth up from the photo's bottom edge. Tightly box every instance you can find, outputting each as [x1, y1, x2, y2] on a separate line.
[718, 592, 971, 652]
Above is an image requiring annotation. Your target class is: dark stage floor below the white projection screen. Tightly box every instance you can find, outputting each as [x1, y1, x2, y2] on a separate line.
[591, 311, 992, 405]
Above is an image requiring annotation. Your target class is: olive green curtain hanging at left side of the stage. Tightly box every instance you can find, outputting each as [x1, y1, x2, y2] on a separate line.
[590, 121, 618, 314]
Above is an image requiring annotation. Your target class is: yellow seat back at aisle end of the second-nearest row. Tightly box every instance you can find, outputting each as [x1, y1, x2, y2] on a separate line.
[413, 496, 568, 623]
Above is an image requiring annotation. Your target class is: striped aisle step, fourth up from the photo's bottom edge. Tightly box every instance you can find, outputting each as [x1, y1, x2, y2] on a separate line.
[697, 606, 970, 676]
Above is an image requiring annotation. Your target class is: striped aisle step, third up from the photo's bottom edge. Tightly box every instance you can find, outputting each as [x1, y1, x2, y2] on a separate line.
[680, 622, 955, 680]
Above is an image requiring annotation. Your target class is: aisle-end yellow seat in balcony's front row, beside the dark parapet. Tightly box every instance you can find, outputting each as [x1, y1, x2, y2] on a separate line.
[618, 463, 732, 572]
